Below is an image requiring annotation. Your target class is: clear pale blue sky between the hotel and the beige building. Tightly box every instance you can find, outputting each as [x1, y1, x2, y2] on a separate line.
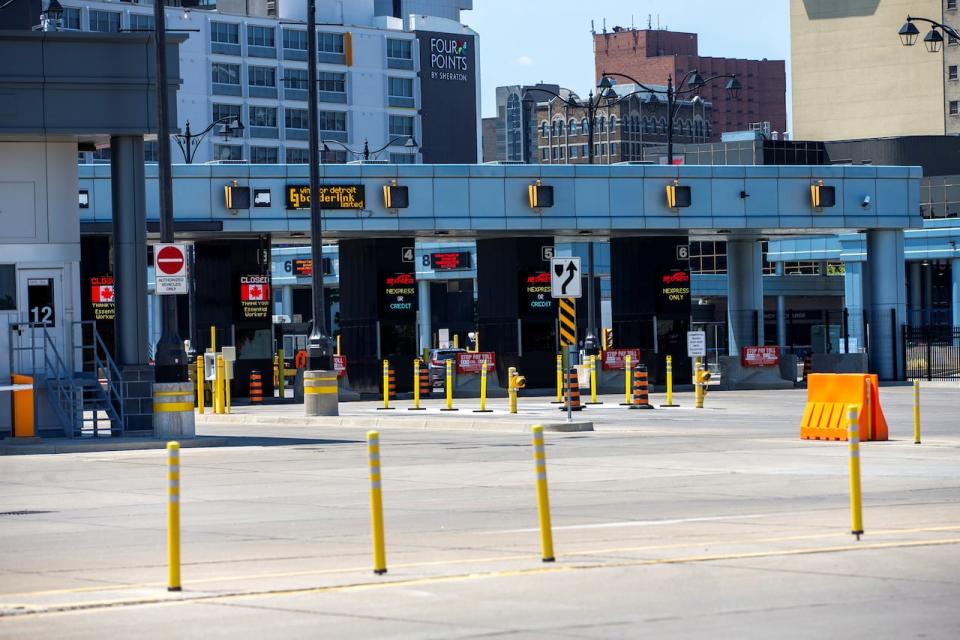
[463, 0, 790, 126]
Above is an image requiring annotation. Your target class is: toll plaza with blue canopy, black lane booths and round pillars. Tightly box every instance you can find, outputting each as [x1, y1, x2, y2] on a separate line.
[69, 164, 920, 424]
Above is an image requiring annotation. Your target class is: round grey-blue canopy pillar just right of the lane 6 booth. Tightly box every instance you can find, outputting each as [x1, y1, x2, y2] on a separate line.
[727, 240, 763, 356]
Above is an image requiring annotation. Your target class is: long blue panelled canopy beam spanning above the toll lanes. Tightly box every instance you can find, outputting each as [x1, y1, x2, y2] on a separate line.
[79, 164, 922, 238]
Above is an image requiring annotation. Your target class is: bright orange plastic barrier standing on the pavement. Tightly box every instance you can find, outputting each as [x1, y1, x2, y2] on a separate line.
[800, 373, 887, 441]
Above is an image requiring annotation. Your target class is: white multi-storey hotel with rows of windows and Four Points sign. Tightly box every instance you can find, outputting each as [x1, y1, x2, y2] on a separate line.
[63, 0, 480, 164]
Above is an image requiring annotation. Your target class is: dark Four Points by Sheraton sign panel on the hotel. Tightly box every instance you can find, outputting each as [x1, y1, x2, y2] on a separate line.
[417, 31, 478, 164]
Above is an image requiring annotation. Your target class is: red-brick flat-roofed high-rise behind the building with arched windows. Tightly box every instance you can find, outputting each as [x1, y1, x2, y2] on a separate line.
[593, 27, 787, 140]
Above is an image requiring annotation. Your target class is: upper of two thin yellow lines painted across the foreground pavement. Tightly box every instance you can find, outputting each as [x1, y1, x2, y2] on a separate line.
[0, 525, 960, 607]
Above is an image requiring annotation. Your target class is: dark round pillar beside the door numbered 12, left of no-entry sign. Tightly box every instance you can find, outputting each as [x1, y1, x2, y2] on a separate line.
[110, 136, 149, 366]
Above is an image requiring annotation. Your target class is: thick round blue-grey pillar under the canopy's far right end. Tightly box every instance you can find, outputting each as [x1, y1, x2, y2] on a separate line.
[864, 229, 907, 380]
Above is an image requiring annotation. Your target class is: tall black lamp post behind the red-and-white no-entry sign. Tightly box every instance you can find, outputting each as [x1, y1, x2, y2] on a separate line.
[153, 0, 187, 383]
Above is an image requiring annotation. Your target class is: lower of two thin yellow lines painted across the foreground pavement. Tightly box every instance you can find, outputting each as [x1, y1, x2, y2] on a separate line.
[0, 538, 960, 619]
